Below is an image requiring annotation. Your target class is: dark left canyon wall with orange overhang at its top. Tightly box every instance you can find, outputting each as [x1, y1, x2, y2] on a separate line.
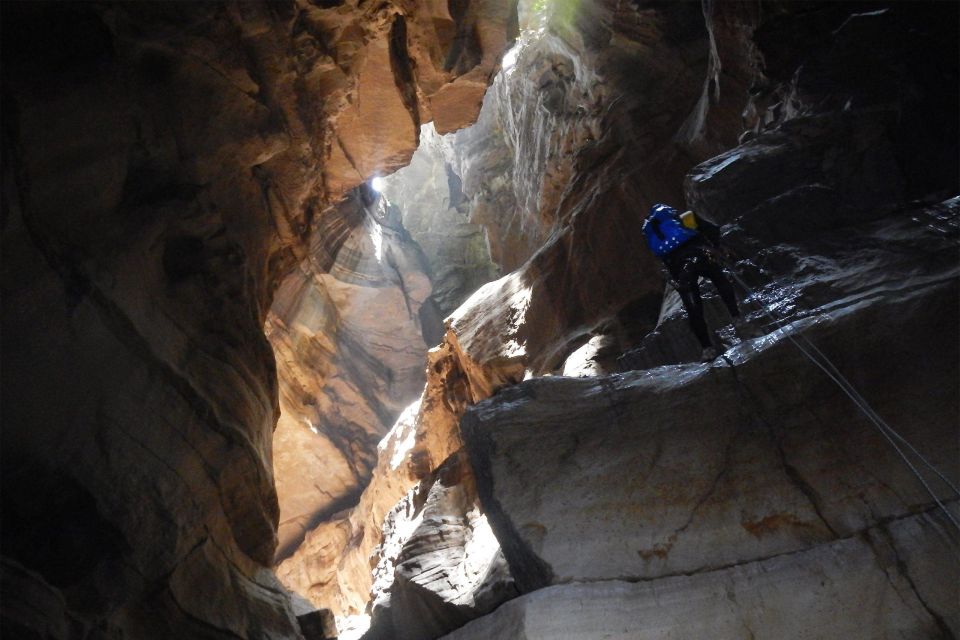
[2, 1, 513, 639]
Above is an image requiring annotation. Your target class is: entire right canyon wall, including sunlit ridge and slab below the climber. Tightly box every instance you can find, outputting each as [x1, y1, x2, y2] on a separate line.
[279, 2, 958, 638]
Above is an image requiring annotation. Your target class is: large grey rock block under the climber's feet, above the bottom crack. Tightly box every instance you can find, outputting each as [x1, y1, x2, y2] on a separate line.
[461, 210, 960, 576]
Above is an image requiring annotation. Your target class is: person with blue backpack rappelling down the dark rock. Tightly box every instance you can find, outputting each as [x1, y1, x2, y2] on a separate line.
[643, 204, 756, 362]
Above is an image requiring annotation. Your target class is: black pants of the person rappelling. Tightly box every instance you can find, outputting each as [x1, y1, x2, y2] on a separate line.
[663, 240, 740, 348]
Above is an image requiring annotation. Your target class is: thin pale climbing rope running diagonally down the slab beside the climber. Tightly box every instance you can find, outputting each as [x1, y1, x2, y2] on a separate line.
[725, 264, 960, 532]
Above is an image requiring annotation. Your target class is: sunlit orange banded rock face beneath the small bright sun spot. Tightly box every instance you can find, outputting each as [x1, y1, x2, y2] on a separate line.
[266, 194, 442, 558]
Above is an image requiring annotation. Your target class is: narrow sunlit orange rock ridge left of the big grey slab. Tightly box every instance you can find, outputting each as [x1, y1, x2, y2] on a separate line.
[278, 268, 526, 616]
